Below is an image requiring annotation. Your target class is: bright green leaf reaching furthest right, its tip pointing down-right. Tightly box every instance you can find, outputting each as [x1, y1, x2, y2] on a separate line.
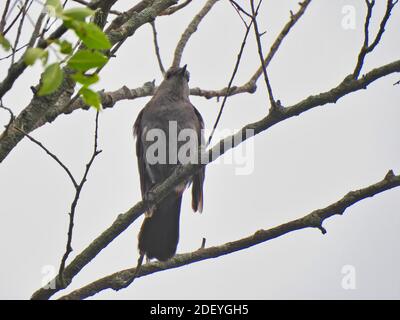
[71, 21, 111, 50]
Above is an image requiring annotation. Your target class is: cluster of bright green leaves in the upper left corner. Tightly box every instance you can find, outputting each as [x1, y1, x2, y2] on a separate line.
[21, 0, 111, 110]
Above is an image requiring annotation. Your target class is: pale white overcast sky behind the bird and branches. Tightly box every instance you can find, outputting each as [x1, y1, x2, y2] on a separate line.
[0, 0, 400, 299]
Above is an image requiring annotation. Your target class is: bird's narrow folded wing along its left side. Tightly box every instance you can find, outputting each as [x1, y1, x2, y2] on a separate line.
[133, 109, 151, 197]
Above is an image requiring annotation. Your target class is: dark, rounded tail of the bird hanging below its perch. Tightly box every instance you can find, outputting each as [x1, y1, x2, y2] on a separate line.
[138, 194, 182, 261]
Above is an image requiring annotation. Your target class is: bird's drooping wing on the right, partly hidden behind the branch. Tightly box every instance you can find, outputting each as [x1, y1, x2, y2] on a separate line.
[192, 105, 206, 212]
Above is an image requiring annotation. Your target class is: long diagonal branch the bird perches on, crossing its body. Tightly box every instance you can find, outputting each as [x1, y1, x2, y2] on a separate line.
[32, 60, 400, 299]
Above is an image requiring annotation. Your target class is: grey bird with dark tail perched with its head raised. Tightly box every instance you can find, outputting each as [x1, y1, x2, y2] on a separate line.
[133, 65, 205, 261]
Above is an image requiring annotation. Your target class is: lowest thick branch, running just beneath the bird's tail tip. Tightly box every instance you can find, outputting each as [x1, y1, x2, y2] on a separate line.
[61, 171, 400, 300]
